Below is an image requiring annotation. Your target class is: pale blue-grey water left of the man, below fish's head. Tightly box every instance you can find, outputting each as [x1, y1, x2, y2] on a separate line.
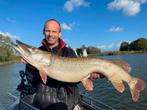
[0, 64, 24, 110]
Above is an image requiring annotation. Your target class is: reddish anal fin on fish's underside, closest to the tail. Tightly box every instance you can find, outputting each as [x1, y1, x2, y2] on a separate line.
[111, 81, 125, 93]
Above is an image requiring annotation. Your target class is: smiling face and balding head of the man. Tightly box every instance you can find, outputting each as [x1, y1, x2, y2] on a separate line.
[44, 21, 61, 47]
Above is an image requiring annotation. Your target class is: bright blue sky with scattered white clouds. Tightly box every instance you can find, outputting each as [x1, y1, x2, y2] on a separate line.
[0, 0, 147, 51]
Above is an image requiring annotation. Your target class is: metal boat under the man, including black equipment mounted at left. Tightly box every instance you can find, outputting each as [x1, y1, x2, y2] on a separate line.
[3, 71, 115, 110]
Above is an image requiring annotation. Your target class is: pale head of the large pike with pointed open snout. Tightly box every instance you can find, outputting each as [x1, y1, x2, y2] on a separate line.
[12, 40, 51, 69]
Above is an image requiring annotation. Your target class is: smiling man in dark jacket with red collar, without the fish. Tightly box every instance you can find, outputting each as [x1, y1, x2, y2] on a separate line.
[22, 19, 98, 110]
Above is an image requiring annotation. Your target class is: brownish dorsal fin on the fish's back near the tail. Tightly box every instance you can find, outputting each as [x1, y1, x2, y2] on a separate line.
[109, 60, 131, 73]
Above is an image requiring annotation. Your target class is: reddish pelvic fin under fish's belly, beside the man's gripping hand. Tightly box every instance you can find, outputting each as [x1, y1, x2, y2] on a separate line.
[81, 79, 93, 91]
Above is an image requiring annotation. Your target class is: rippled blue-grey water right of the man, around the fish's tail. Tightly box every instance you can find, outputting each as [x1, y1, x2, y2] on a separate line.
[87, 54, 147, 110]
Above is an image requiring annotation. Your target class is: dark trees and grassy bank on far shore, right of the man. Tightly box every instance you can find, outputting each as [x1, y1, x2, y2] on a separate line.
[76, 38, 147, 55]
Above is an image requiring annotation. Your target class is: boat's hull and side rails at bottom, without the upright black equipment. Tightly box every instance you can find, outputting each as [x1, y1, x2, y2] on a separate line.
[3, 94, 115, 110]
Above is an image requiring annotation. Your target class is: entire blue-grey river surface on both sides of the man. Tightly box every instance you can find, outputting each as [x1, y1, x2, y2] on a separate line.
[0, 53, 147, 110]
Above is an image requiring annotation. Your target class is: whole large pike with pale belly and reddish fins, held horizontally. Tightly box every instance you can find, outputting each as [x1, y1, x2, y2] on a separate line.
[13, 41, 145, 102]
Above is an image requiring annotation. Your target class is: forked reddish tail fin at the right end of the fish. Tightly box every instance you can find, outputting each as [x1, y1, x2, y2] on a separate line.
[129, 77, 145, 102]
